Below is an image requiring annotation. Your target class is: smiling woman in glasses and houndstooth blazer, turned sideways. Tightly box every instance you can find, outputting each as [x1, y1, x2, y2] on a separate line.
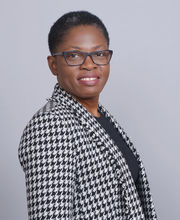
[19, 11, 157, 220]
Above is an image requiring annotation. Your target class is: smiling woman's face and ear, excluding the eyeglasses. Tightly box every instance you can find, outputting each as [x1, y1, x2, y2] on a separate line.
[48, 25, 109, 100]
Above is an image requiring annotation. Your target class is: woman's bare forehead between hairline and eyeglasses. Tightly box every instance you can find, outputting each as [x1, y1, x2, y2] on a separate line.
[58, 25, 107, 50]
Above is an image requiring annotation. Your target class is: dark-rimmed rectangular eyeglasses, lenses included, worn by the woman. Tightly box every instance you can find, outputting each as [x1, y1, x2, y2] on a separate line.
[52, 50, 113, 66]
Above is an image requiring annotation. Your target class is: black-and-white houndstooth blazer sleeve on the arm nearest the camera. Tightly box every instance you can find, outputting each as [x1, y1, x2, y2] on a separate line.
[19, 113, 75, 220]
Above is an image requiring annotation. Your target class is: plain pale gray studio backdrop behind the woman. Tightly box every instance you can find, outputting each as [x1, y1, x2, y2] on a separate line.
[0, 0, 180, 220]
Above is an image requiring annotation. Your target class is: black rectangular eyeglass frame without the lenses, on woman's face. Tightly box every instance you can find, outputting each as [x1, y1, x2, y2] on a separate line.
[52, 50, 113, 66]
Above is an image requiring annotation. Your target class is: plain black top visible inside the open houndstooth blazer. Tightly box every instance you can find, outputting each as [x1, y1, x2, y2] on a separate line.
[95, 113, 139, 183]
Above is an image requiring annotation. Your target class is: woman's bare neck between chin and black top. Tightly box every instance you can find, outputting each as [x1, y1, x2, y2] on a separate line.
[75, 97, 100, 117]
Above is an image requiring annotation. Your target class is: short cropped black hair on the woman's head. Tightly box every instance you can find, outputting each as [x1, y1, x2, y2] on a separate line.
[48, 11, 109, 54]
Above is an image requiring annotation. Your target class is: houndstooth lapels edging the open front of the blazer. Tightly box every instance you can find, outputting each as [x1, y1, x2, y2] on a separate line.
[51, 84, 145, 219]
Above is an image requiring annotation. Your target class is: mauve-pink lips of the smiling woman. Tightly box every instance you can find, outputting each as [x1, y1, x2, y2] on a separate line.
[78, 73, 100, 86]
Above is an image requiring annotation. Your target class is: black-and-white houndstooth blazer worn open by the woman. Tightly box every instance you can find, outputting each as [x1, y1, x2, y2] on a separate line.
[19, 84, 157, 220]
